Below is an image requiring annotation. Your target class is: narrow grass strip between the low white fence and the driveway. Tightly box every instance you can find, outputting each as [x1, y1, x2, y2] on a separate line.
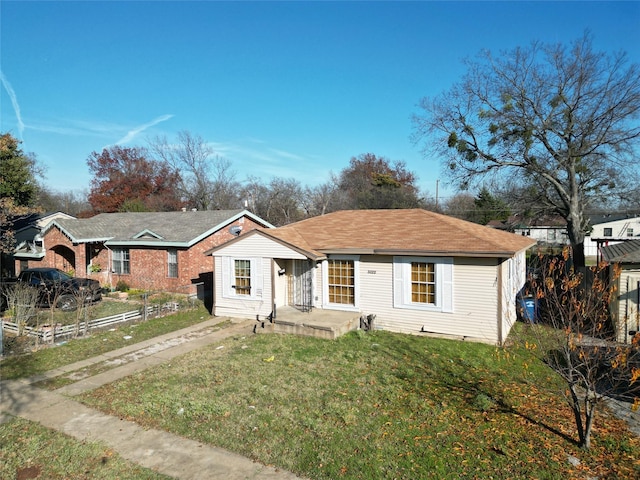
[0, 306, 214, 380]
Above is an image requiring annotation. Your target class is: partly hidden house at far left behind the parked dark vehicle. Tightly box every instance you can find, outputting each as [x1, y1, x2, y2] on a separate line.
[2, 212, 75, 277]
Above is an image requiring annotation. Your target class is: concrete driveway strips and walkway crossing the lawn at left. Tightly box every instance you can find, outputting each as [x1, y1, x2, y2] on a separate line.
[0, 319, 298, 480]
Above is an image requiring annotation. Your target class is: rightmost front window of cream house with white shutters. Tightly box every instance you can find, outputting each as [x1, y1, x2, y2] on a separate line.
[393, 257, 453, 312]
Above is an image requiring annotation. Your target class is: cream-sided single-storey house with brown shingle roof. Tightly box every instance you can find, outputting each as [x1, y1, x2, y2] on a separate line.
[207, 209, 536, 344]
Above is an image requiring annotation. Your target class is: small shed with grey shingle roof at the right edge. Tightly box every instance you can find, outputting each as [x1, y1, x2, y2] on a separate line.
[601, 239, 640, 343]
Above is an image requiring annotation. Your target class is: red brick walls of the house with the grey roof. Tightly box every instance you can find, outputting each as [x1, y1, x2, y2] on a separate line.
[19, 217, 261, 294]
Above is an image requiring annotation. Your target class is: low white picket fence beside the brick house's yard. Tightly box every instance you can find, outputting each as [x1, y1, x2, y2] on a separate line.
[2, 303, 179, 343]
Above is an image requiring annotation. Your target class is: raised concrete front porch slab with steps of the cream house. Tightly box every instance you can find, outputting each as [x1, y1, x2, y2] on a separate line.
[254, 307, 360, 340]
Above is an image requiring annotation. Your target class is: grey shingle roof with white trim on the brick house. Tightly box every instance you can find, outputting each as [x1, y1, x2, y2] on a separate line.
[43, 210, 273, 247]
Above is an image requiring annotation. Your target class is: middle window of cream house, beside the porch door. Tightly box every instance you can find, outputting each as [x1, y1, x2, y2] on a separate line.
[323, 255, 360, 309]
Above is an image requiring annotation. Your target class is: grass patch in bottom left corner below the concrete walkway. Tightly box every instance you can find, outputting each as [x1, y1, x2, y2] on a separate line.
[0, 418, 170, 480]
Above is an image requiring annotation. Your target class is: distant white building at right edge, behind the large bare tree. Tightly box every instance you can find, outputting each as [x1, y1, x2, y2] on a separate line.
[584, 215, 640, 261]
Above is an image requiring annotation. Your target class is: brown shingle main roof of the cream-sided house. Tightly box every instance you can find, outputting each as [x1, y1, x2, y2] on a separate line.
[266, 209, 536, 256]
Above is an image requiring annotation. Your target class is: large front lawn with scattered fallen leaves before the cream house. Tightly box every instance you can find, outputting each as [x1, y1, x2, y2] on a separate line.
[74, 326, 640, 479]
